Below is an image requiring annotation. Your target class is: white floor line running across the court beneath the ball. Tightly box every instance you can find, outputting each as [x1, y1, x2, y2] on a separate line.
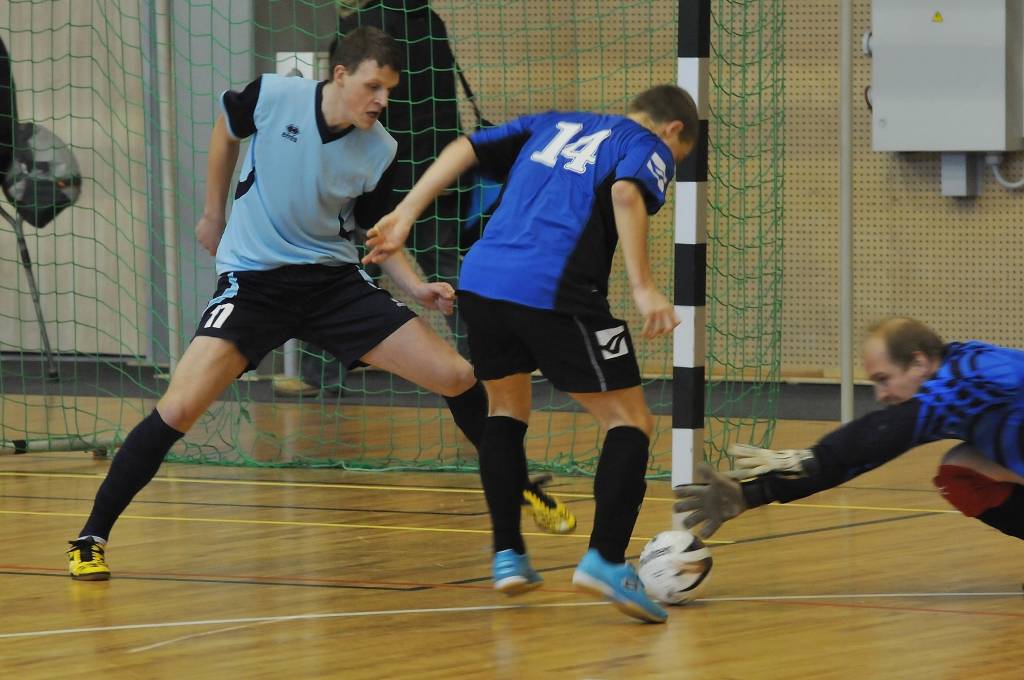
[0, 591, 1022, 651]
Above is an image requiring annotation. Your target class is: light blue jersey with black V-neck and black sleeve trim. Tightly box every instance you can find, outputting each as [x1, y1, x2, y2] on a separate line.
[217, 75, 397, 274]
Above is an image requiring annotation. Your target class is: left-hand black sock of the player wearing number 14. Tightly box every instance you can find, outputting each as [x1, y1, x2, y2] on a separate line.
[479, 416, 526, 554]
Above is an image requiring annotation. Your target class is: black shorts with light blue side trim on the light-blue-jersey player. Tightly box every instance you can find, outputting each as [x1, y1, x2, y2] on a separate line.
[196, 264, 416, 369]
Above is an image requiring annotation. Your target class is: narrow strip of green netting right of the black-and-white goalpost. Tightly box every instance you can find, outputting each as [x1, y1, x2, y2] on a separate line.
[705, 0, 784, 462]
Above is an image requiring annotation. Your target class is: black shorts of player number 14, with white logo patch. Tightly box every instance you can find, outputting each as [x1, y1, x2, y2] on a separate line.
[459, 291, 640, 392]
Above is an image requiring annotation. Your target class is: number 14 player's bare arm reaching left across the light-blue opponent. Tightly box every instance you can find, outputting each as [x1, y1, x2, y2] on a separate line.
[362, 137, 476, 264]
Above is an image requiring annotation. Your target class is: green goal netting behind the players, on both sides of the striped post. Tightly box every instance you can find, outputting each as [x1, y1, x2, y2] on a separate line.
[0, 0, 782, 474]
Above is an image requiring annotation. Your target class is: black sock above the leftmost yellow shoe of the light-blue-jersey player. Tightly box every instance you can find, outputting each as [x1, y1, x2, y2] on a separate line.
[79, 409, 184, 540]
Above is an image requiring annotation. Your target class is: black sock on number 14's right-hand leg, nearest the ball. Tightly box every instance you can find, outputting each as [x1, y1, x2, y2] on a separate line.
[590, 427, 650, 563]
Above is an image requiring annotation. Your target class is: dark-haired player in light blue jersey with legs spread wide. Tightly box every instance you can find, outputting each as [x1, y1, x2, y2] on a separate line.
[68, 28, 499, 581]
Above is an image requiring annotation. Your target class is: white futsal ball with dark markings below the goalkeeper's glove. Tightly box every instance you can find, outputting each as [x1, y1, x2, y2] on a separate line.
[637, 530, 712, 604]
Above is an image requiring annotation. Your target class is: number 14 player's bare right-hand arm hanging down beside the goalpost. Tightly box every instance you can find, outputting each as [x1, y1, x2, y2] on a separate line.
[611, 180, 679, 338]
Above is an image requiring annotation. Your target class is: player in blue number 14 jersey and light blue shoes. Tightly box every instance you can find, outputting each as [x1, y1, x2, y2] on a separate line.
[367, 85, 699, 623]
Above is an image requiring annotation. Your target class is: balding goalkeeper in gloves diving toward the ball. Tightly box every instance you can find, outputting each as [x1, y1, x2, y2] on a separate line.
[676, 317, 1024, 539]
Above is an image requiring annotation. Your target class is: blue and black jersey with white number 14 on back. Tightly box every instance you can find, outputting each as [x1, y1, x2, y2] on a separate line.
[459, 112, 675, 313]
